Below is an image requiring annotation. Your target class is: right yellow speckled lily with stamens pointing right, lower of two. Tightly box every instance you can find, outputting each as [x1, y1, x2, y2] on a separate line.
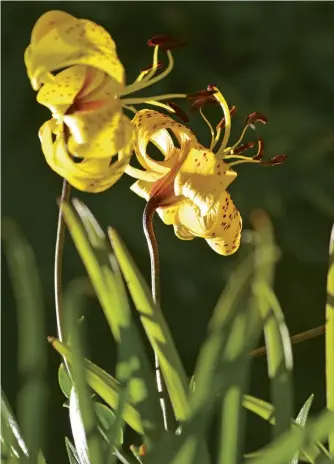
[126, 87, 283, 256]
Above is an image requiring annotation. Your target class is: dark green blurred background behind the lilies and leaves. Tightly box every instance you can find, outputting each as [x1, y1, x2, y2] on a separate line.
[1, 2, 334, 463]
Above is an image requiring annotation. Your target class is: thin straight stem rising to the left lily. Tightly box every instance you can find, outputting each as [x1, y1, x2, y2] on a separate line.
[54, 179, 71, 342]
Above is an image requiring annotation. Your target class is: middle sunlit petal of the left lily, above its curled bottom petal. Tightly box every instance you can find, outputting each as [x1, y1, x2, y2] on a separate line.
[64, 109, 134, 158]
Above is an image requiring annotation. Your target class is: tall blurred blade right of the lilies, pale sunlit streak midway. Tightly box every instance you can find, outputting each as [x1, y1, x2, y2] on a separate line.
[253, 211, 293, 438]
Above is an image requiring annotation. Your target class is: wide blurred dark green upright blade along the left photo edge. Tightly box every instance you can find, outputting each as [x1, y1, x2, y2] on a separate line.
[2, 219, 47, 461]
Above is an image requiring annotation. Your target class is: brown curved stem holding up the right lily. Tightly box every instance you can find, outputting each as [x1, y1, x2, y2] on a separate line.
[143, 198, 175, 430]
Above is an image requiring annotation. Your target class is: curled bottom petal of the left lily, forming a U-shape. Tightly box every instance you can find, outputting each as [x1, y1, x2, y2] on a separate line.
[39, 120, 131, 193]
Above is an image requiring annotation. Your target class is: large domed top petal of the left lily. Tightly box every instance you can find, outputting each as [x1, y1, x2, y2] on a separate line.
[25, 12, 124, 91]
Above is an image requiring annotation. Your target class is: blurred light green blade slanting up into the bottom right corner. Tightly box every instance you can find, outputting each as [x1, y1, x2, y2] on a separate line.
[247, 411, 334, 464]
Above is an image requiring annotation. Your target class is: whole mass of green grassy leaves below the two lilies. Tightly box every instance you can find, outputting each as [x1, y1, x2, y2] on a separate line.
[1, 207, 334, 464]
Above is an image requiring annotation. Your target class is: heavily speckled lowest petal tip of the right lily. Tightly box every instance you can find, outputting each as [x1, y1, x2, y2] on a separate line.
[206, 192, 242, 256]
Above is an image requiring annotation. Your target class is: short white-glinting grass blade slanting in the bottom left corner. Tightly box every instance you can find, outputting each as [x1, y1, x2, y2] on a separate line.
[1, 389, 29, 462]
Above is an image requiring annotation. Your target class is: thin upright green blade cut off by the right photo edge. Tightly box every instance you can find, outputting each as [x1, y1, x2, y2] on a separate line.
[326, 226, 334, 459]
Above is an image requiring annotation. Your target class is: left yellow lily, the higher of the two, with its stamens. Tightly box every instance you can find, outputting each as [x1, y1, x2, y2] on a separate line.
[24, 11, 186, 192]
